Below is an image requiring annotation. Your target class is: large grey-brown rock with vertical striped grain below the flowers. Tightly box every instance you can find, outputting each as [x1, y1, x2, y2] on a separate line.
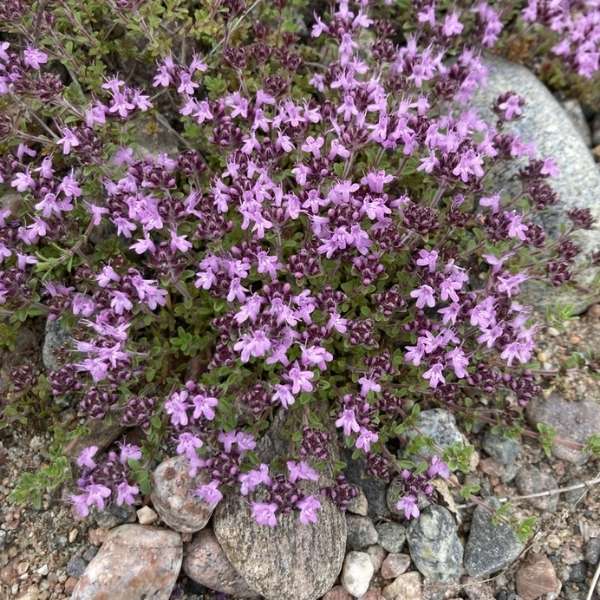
[213, 495, 346, 600]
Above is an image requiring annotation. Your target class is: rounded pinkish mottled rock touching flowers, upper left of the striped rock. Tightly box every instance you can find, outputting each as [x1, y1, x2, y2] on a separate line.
[151, 456, 214, 533]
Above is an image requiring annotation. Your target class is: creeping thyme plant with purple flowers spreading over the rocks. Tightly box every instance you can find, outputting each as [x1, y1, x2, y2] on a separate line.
[0, 0, 600, 526]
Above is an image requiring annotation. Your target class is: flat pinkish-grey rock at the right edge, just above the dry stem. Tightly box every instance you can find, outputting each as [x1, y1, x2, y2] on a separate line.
[527, 394, 600, 464]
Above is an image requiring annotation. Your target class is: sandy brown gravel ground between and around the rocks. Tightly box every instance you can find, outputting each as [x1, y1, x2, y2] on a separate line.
[0, 305, 600, 600]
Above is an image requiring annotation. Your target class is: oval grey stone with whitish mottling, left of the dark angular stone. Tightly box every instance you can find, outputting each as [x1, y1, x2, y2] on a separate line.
[407, 505, 463, 581]
